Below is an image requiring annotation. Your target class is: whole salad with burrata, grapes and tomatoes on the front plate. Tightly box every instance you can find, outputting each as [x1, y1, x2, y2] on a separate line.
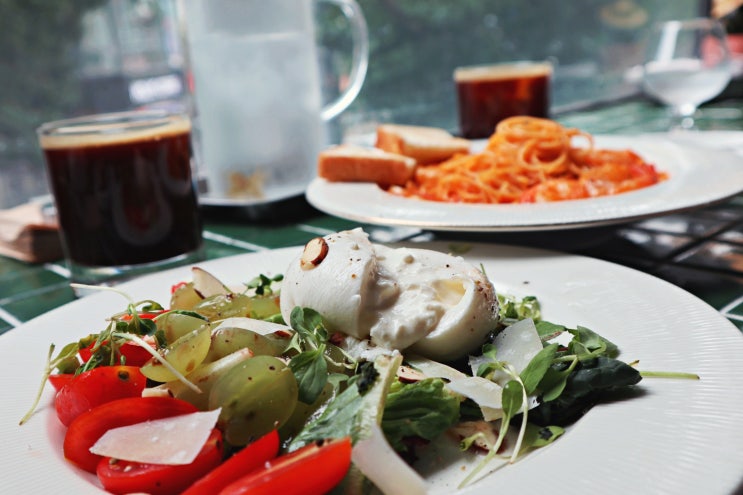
[24, 230, 694, 495]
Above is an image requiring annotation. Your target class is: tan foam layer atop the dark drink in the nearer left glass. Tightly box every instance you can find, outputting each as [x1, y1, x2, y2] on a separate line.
[38, 112, 191, 149]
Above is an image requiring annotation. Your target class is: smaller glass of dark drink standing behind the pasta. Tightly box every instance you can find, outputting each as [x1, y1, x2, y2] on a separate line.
[454, 62, 552, 139]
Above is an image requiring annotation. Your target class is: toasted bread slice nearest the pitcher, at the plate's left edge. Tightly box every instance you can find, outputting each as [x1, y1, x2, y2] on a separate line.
[317, 144, 415, 186]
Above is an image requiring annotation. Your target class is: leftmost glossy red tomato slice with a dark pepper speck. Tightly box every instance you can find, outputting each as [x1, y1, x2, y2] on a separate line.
[54, 366, 147, 426]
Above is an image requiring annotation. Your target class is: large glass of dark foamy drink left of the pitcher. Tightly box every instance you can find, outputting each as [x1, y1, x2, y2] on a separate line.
[37, 110, 203, 284]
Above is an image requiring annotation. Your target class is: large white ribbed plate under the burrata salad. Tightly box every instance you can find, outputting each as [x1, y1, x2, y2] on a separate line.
[0, 239, 743, 495]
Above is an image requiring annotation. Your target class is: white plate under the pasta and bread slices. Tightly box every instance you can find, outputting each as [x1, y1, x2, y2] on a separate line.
[306, 132, 743, 232]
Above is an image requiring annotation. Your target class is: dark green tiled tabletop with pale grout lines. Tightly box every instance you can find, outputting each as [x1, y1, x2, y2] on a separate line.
[0, 100, 743, 333]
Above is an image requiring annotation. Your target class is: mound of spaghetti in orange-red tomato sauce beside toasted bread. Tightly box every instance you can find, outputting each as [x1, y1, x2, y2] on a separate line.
[389, 116, 666, 203]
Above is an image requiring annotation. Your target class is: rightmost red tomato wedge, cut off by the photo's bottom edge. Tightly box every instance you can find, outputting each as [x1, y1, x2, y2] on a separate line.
[219, 437, 351, 495]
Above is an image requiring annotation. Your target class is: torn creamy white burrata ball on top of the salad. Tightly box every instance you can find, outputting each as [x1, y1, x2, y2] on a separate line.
[281, 229, 498, 360]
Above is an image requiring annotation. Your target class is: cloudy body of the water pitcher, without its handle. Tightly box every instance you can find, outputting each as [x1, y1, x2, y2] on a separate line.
[184, 0, 325, 201]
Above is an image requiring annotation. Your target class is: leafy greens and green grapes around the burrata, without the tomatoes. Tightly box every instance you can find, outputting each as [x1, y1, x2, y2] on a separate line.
[23, 272, 664, 493]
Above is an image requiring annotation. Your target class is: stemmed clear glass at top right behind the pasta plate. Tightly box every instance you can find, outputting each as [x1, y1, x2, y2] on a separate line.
[643, 18, 732, 129]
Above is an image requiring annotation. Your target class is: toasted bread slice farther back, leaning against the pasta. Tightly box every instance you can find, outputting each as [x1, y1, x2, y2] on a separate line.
[376, 124, 470, 165]
